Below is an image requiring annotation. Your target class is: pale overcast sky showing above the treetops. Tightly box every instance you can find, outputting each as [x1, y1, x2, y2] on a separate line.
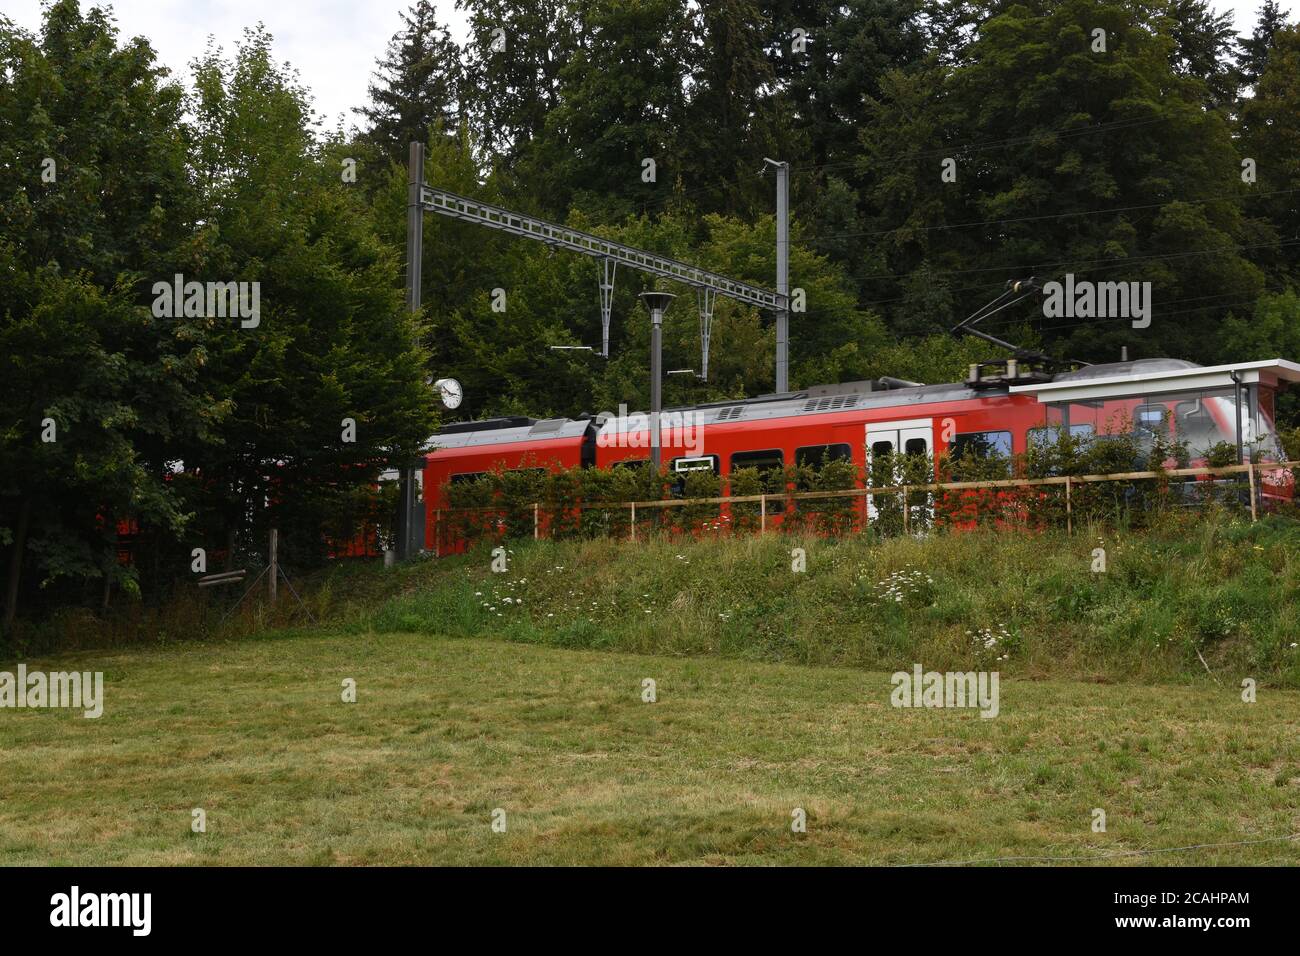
[4, 0, 1300, 127]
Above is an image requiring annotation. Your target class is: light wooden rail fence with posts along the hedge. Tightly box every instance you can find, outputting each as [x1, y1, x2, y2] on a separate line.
[434, 462, 1300, 551]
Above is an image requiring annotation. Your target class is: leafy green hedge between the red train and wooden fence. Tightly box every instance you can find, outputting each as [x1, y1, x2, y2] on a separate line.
[434, 421, 1247, 544]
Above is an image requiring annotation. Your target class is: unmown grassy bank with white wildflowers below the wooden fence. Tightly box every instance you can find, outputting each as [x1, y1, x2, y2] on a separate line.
[335, 519, 1300, 688]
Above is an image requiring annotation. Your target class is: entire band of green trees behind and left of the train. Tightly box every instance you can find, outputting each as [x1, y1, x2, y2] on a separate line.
[0, 0, 1300, 632]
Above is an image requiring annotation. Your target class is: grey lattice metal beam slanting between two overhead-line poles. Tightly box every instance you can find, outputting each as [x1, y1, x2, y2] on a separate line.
[420, 185, 787, 310]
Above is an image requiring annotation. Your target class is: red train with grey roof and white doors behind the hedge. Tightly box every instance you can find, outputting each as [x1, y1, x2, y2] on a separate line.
[423, 359, 1300, 550]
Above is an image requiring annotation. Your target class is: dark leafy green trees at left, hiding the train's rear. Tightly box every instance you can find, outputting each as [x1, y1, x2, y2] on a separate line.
[0, 9, 436, 634]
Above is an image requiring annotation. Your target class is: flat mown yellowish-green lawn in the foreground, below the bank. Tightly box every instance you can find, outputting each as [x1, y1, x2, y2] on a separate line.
[0, 633, 1300, 865]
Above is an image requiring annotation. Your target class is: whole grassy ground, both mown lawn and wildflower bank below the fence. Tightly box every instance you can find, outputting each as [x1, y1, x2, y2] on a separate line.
[10, 519, 1300, 864]
